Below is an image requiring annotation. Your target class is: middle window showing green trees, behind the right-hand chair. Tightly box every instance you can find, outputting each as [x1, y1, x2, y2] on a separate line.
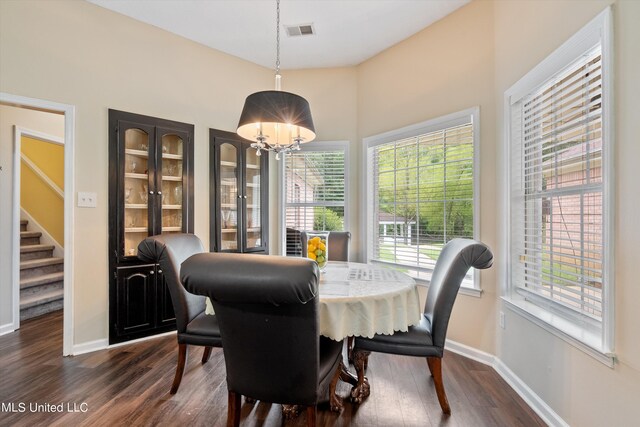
[365, 109, 478, 288]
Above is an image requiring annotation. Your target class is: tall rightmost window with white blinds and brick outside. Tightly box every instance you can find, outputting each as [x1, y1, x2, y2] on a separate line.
[506, 7, 612, 362]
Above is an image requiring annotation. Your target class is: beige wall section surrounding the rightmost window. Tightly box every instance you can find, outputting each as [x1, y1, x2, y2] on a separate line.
[495, 0, 640, 426]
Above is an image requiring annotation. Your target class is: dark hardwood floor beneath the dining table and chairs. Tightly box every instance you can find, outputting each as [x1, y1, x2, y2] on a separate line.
[0, 312, 544, 427]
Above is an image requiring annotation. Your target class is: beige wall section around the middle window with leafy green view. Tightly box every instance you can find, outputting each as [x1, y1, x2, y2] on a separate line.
[358, 1, 498, 353]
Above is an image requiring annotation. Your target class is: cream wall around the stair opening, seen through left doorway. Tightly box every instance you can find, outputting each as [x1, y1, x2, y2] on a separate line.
[0, 106, 64, 327]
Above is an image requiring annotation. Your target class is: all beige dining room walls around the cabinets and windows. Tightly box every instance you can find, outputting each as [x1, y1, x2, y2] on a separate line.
[0, 0, 640, 426]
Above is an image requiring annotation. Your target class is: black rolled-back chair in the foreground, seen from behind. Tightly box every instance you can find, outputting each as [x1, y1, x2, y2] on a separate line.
[181, 253, 343, 426]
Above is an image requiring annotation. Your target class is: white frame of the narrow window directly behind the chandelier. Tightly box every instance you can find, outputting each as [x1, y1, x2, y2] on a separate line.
[278, 140, 349, 255]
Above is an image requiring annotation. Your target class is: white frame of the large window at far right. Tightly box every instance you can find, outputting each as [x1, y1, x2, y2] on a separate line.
[501, 7, 615, 367]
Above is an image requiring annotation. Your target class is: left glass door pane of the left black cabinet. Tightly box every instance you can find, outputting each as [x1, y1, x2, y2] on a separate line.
[122, 128, 150, 256]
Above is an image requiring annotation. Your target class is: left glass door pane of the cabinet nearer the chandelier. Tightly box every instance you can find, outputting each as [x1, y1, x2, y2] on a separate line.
[218, 143, 239, 251]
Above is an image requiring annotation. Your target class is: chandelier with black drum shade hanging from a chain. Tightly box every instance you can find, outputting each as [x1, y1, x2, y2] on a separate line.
[236, 0, 316, 160]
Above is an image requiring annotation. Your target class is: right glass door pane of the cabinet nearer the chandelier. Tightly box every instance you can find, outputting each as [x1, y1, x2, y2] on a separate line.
[243, 148, 263, 249]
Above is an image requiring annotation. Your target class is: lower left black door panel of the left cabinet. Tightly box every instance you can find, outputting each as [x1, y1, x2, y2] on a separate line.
[116, 264, 155, 335]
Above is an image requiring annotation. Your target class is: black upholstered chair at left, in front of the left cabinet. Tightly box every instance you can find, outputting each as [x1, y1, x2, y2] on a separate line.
[138, 234, 222, 394]
